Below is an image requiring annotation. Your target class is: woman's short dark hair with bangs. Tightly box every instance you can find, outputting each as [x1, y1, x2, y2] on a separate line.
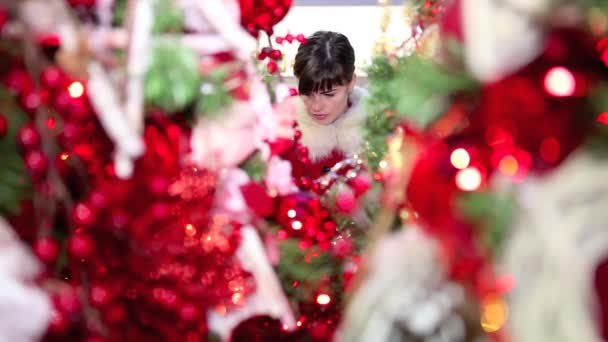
[293, 31, 355, 95]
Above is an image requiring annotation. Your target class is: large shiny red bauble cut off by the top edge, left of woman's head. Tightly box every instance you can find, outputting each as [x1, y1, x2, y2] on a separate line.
[239, 0, 292, 37]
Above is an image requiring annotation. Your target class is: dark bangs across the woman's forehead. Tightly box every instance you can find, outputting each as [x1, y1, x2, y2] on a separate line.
[298, 63, 352, 95]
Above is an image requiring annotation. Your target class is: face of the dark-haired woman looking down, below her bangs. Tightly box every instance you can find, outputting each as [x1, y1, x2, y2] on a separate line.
[302, 77, 355, 125]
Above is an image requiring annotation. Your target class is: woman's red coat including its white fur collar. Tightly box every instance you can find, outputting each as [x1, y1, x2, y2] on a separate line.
[282, 87, 367, 181]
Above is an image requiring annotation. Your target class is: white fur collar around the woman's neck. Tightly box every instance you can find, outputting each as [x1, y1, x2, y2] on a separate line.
[296, 87, 368, 161]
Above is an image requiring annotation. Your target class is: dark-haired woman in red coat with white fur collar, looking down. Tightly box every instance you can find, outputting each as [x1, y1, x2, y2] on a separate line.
[286, 31, 367, 183]
